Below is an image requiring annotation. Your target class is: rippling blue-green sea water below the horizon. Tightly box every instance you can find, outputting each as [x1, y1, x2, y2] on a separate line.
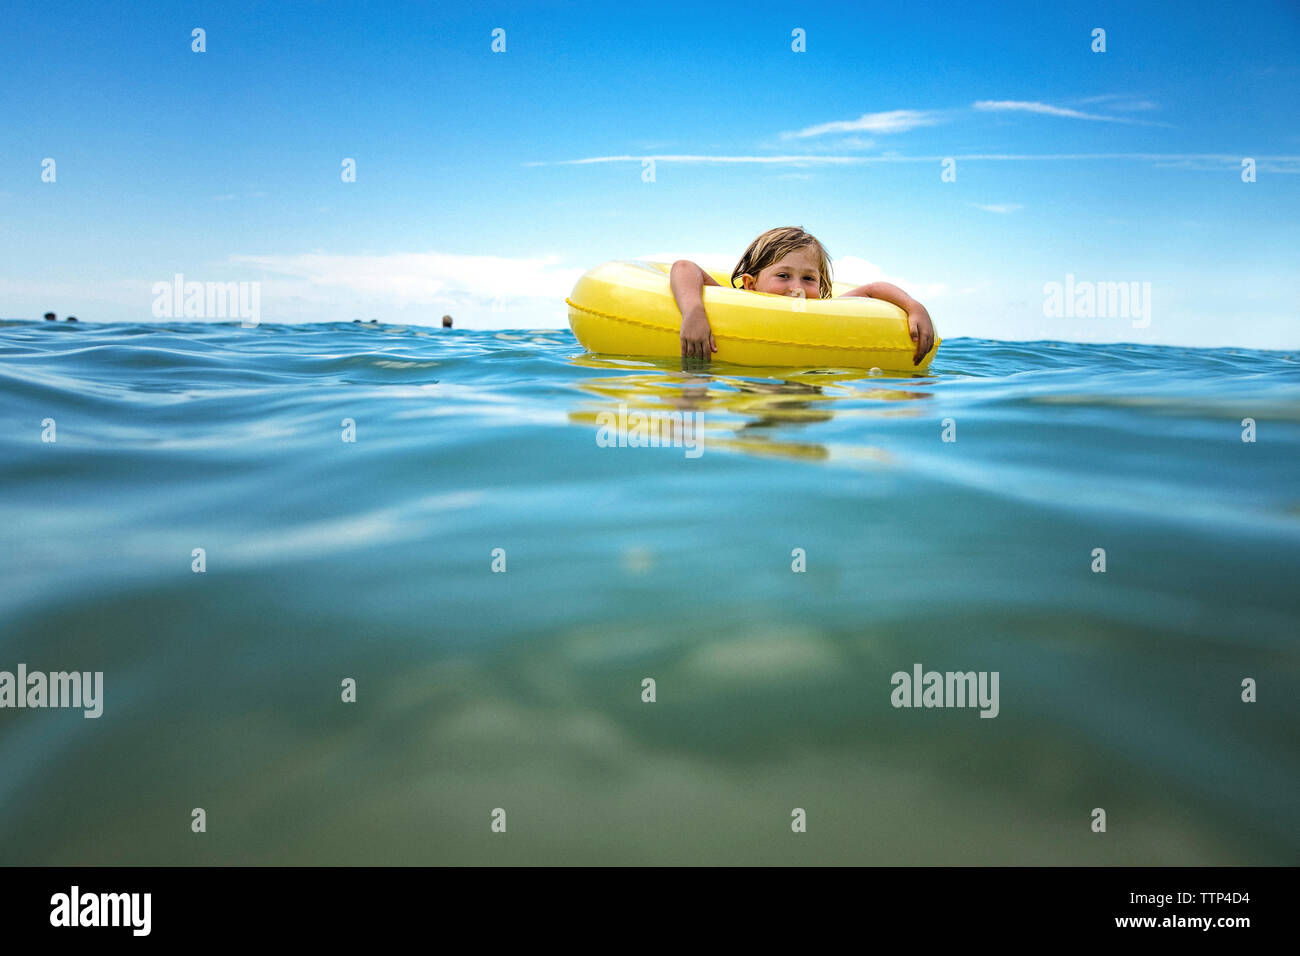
[0, 321, 1300, 865]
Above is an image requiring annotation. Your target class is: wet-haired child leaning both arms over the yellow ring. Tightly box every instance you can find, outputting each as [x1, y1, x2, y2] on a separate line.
[668, 226, 935, 365]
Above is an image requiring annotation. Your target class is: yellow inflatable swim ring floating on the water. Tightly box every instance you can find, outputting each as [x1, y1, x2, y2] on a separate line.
[566, 261, 940, 372]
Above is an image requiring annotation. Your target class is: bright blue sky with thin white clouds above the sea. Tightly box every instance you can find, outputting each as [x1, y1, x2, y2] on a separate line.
[0, 0, 1300, 349]
